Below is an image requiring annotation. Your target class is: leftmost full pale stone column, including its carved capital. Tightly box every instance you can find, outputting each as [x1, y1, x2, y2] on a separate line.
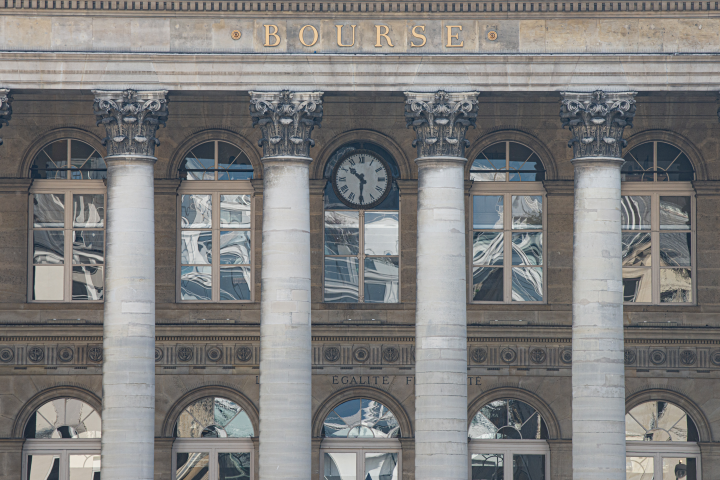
[93, 90, 168, 480]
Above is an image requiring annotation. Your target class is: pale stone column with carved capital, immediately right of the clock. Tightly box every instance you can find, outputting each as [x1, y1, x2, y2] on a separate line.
[405, 91, 478, 480]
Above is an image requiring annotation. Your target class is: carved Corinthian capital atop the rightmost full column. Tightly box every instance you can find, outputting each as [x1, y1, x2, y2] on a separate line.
[560, 90, 637, 158]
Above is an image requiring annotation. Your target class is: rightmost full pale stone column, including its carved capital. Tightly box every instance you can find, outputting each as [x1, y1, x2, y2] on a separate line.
[560, 91, 635, 480]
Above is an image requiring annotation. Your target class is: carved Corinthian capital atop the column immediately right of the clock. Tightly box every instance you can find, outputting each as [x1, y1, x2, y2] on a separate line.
[405, 90, 479, 158]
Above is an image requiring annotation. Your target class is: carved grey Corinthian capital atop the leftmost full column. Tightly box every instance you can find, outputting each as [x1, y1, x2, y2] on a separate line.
[93, 90, 168, 157]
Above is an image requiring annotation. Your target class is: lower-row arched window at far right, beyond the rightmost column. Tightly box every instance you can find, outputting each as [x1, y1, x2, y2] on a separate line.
[625, 401, 701, 480]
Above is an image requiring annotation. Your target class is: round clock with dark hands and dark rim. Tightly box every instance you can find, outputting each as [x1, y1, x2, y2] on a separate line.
[332, 150, 390, 208]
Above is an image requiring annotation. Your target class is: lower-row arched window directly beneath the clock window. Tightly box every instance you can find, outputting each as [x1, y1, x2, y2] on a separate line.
[320, 398, 402, 480]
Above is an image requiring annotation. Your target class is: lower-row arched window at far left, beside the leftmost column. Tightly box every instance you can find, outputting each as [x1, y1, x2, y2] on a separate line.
[23, 398, 101, 480]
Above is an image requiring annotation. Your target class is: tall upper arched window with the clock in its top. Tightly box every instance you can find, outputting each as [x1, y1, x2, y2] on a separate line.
[324, 142, 400, 303]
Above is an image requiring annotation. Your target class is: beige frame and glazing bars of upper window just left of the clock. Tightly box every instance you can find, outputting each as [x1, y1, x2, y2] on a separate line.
[176, 139, 255, 303]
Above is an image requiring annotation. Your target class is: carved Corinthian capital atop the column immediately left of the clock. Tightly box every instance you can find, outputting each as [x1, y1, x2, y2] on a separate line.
[250, 90, 323, 158]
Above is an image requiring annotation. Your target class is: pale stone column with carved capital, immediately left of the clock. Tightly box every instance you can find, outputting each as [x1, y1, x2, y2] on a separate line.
[250, 90, 322, 480]
